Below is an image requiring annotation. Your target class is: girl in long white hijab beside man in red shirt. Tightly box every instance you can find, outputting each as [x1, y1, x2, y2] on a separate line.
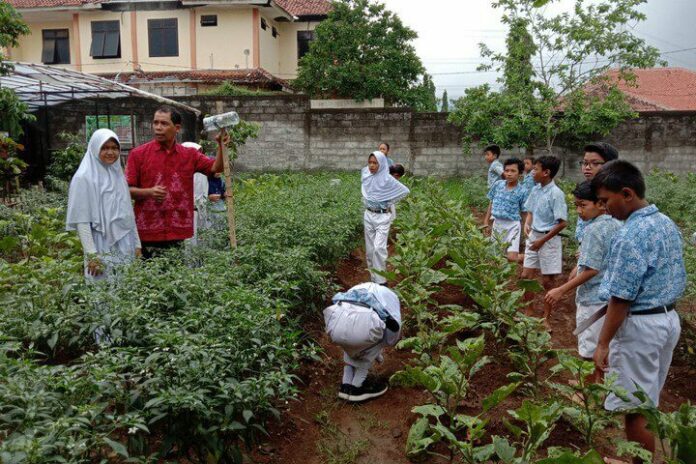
[66, 129, 140, 280]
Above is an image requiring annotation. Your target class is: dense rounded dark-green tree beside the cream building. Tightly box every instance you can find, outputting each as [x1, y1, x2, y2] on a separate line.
[295, 0, 430, 107]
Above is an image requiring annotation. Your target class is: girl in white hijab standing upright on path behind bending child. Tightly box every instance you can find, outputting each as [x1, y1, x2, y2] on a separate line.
[362, 151, 409, 285]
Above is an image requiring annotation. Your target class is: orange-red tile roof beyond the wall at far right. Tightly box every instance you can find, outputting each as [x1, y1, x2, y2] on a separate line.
[609, 68, 696, 111]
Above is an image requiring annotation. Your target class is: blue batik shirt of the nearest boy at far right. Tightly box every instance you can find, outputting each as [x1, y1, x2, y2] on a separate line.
[599, 205, 686, 312]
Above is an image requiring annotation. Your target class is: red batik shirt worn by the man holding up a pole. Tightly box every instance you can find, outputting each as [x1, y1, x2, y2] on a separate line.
[126, 140, 215, 242]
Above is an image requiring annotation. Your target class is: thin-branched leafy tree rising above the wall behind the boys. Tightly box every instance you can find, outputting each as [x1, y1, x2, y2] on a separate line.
[451, 0, 660, 156]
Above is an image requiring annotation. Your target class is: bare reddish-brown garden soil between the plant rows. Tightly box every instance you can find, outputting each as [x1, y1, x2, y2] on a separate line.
[248, 245, 696, 464]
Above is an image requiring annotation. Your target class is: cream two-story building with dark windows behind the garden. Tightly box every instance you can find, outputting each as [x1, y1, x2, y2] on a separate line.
[3, 0, 331, 96]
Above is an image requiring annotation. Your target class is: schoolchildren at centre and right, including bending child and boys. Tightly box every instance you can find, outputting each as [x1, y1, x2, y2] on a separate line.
[324, 142, 686, 458]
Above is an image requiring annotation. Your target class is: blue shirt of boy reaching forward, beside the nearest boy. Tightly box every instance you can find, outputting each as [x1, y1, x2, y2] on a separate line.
[575, 214, 622, 306]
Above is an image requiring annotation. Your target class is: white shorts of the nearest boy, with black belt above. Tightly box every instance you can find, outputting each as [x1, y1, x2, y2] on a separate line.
[604, 311, 681, 411]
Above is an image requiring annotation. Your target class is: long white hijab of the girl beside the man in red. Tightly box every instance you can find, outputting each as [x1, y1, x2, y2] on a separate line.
[66, 129, 136, 251]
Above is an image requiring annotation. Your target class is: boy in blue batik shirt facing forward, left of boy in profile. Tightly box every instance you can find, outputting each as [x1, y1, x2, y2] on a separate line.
[483, 158, 527, 263]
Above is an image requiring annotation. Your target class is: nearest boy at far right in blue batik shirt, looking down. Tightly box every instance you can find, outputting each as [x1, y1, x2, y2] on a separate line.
[592, 160, 686, 462]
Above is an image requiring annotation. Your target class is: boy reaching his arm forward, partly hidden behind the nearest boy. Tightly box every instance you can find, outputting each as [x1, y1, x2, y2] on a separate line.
[544, 181, 621, 360]
